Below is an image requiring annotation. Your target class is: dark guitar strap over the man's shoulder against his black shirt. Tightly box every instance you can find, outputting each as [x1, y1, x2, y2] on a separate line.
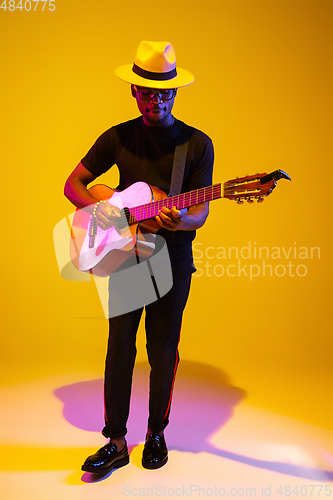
[168, 122, 189, 196]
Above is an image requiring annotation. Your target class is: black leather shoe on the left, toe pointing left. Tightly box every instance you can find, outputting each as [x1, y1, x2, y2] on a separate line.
[81, 441, 129, 474]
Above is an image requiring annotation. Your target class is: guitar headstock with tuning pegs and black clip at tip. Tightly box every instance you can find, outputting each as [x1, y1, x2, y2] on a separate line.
[223, 170, 291, 205]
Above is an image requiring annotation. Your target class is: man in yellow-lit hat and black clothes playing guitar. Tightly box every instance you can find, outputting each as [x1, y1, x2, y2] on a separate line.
[65, 41, 214, 474]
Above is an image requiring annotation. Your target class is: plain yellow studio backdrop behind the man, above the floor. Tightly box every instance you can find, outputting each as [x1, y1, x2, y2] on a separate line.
[0, 0, 333, 429]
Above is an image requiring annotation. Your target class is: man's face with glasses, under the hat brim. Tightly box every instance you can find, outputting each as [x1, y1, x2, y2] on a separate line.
[131, 85, 177, 127]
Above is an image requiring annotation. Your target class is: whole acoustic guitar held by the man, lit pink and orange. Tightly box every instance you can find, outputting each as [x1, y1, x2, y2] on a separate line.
[70, 170, 291, 277]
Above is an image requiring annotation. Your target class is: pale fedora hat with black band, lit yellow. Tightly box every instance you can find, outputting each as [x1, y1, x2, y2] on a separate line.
[115, 41, 194, 89]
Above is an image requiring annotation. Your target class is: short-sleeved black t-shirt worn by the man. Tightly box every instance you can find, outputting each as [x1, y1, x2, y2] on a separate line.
[81, 117, 214, 277]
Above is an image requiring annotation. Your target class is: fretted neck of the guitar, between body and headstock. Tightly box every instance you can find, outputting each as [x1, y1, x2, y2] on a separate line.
[128, 183, 223, 224]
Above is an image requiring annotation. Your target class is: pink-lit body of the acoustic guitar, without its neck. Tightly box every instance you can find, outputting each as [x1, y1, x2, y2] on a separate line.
[70, 182, 167, 277]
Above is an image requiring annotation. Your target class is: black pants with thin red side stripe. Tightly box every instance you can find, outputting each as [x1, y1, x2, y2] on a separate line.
[102, 276, 191, 439]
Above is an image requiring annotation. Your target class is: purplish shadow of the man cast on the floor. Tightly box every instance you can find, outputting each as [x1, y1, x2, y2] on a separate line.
[55, 361, 333, 482]
